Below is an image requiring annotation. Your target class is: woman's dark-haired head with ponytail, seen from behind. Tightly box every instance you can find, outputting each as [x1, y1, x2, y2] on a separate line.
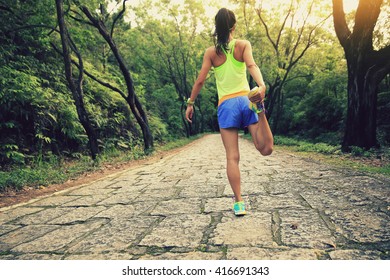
[213, 8, 236, 55]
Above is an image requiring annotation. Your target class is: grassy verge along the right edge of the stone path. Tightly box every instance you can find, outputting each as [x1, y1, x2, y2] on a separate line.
[244, 134, 390, 176]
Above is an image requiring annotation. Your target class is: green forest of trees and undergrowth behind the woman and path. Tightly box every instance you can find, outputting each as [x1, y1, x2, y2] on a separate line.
[0, 0, 390, 191]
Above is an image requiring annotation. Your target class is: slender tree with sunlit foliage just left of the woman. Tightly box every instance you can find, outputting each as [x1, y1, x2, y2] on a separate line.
[129, 0, 212, 136]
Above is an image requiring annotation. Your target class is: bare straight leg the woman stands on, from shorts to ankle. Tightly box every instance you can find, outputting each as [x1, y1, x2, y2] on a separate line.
[220, 128, 242, 202]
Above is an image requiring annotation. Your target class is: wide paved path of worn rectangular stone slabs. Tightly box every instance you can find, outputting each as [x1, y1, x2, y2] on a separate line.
[0, 135, 390, 260]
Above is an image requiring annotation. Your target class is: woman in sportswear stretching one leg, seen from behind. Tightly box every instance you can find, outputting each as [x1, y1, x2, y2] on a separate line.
[186, 8, 273, 216]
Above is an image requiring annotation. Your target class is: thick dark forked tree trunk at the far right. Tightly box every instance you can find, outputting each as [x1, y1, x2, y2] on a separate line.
[333, 0, 390, 151]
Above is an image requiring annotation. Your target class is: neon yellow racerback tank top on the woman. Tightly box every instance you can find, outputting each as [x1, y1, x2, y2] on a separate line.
[214, 40, 250, 99]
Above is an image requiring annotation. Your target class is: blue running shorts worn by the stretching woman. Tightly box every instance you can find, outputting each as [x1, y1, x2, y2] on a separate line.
[218, 96, 259, 129]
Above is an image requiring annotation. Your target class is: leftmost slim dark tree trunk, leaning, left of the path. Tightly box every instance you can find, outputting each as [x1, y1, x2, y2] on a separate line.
[56, 0, 99, 159]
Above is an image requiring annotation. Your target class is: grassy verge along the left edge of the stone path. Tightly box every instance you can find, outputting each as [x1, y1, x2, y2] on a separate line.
[0, 135, 202, 192]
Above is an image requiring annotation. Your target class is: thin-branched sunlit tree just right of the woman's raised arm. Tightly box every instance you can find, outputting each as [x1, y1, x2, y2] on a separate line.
[256, 0, 330, 132]
